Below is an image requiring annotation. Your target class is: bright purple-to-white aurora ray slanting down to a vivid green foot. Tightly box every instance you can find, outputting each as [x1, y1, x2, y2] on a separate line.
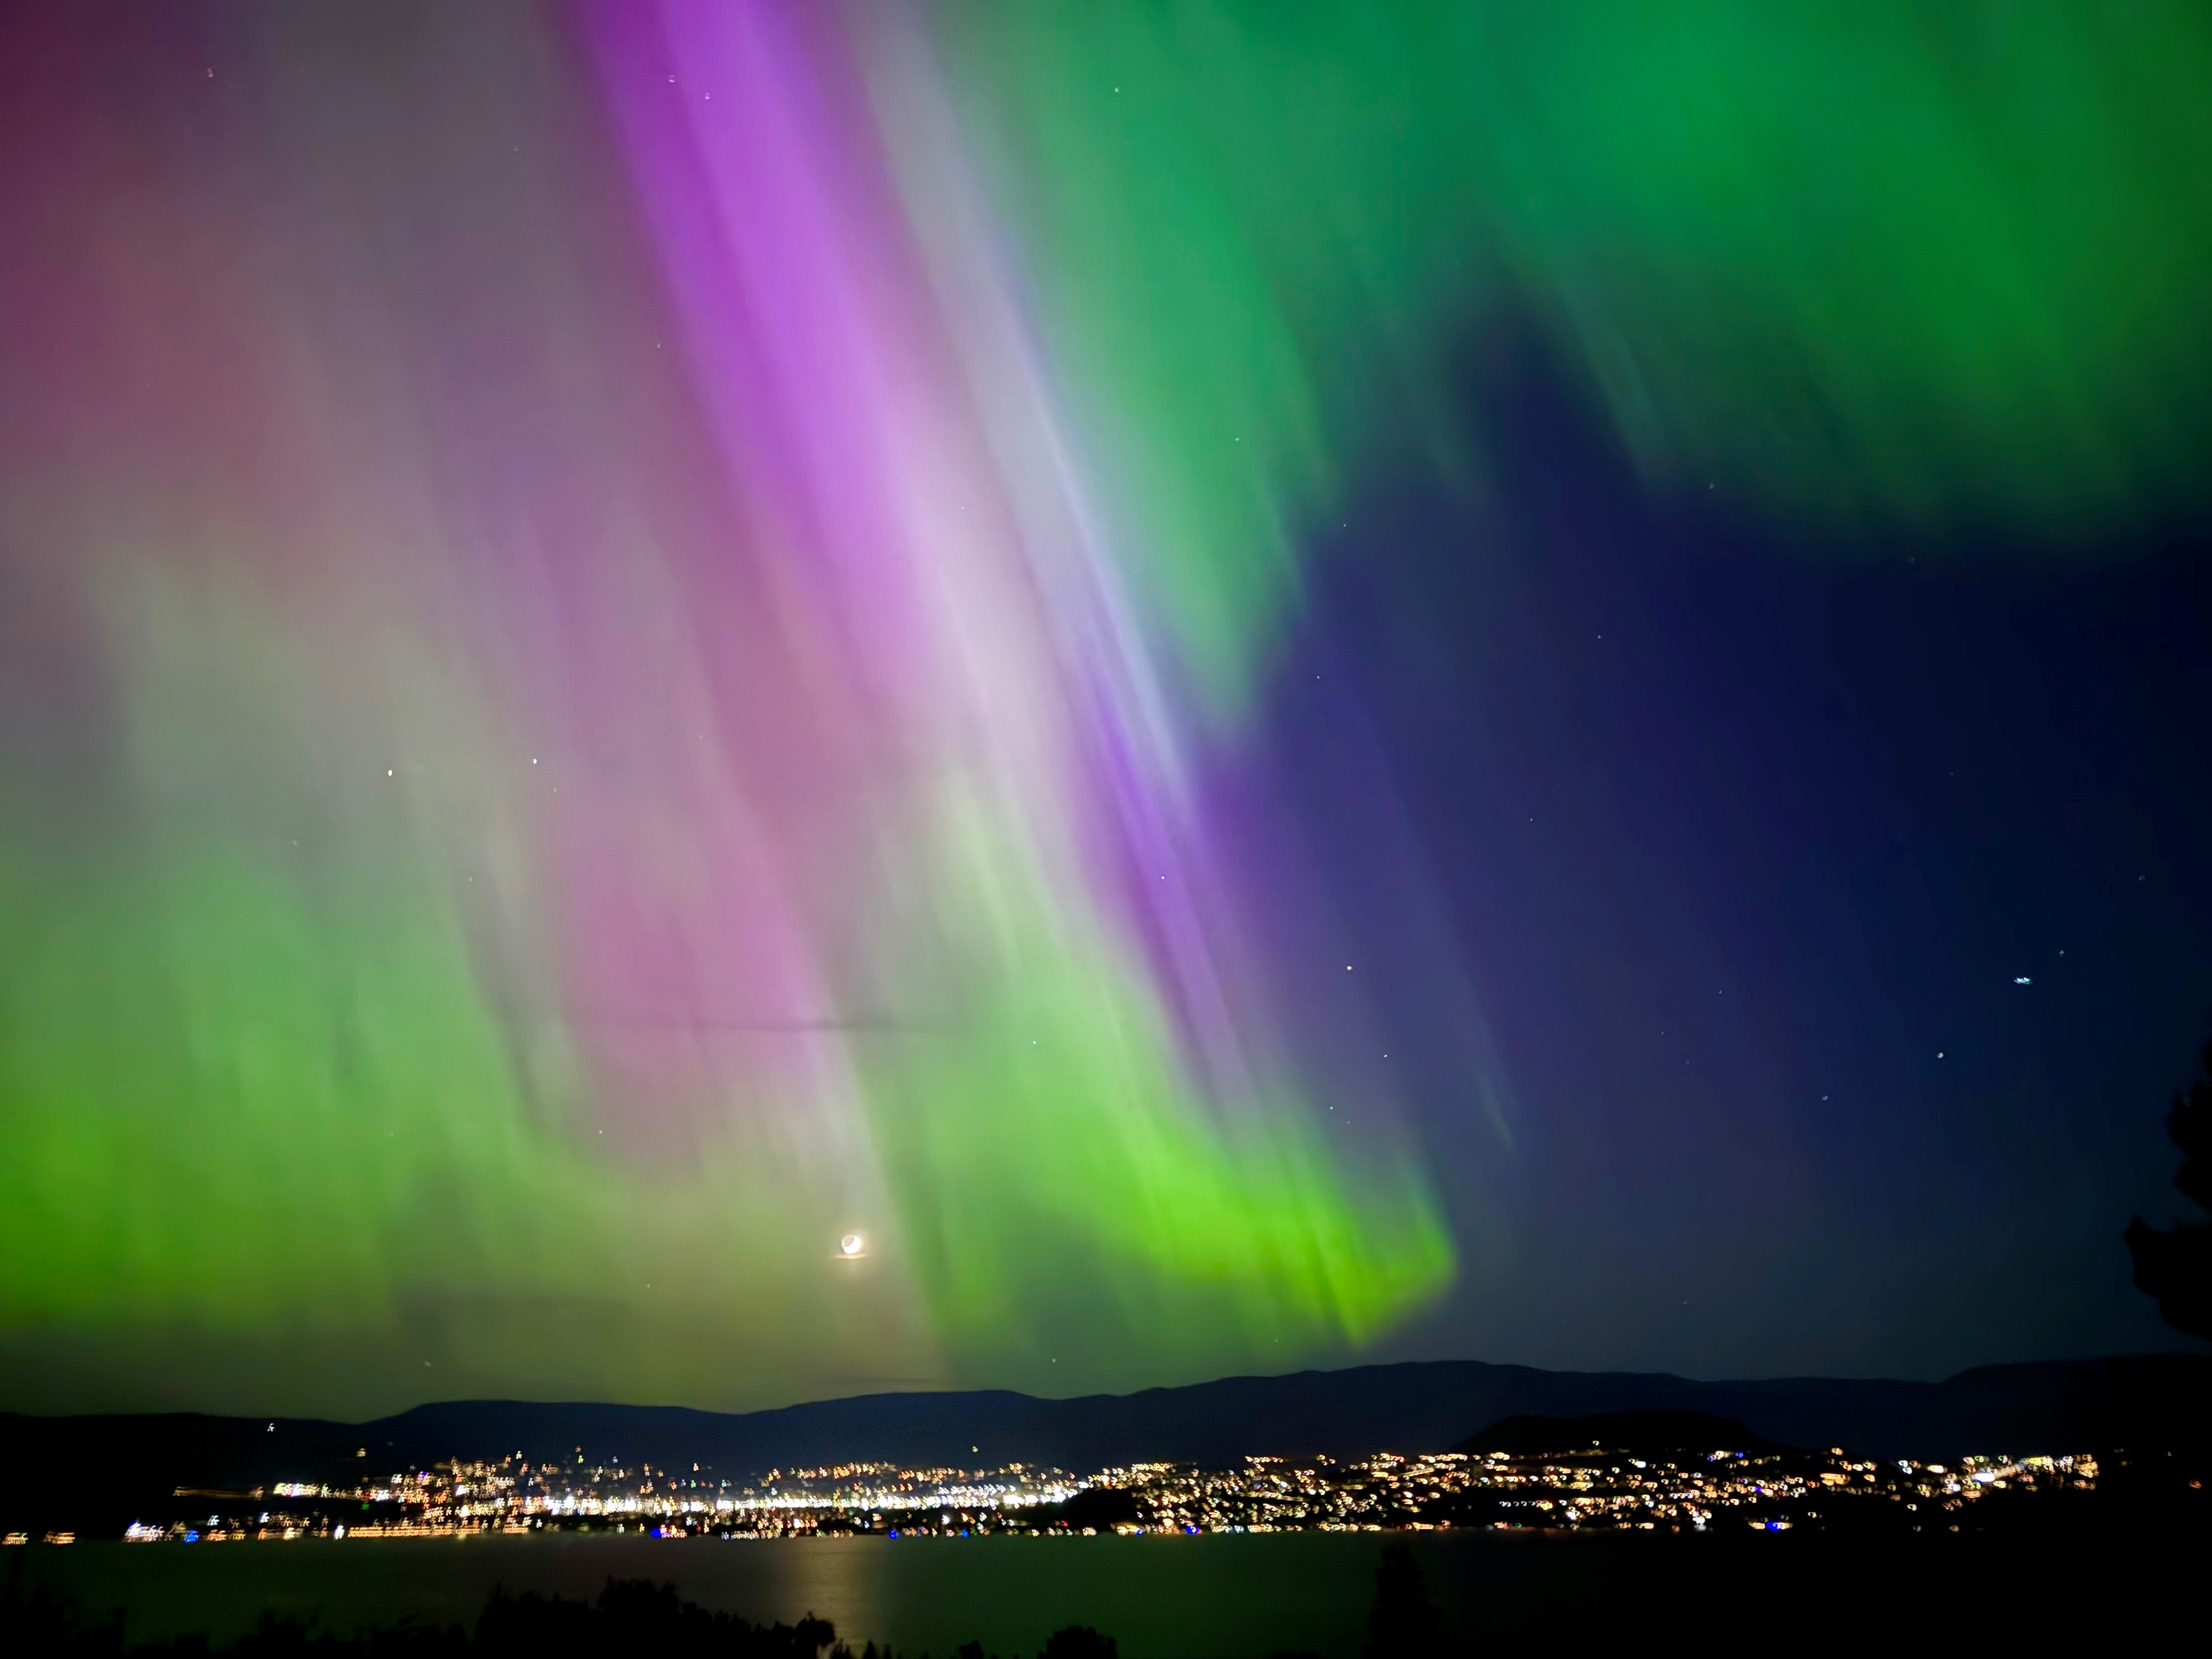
[595, 9, 1449, 1372]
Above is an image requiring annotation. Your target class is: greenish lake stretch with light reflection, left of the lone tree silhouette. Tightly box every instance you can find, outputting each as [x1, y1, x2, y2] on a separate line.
[33, 1533, 1380, 1659]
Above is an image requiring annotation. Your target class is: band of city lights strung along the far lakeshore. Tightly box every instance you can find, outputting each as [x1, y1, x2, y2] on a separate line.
[74, 1447, 2099, 1544]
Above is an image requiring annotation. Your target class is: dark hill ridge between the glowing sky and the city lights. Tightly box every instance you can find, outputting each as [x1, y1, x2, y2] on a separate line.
[0, 1356, 2212, 1509]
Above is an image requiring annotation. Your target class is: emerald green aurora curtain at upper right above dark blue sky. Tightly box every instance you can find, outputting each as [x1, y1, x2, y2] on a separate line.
[929, 0, 2212, 710]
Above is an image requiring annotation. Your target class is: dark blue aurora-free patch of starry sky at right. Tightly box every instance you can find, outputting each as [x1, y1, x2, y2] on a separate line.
[1269, 336, 2212, 1376]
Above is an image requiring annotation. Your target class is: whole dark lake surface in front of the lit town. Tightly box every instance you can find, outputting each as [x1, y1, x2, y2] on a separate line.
[9, 1533, 2188, 1659]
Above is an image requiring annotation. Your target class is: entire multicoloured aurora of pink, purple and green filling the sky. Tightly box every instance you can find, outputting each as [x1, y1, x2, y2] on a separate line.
[0, 0, 2212, 1411]
